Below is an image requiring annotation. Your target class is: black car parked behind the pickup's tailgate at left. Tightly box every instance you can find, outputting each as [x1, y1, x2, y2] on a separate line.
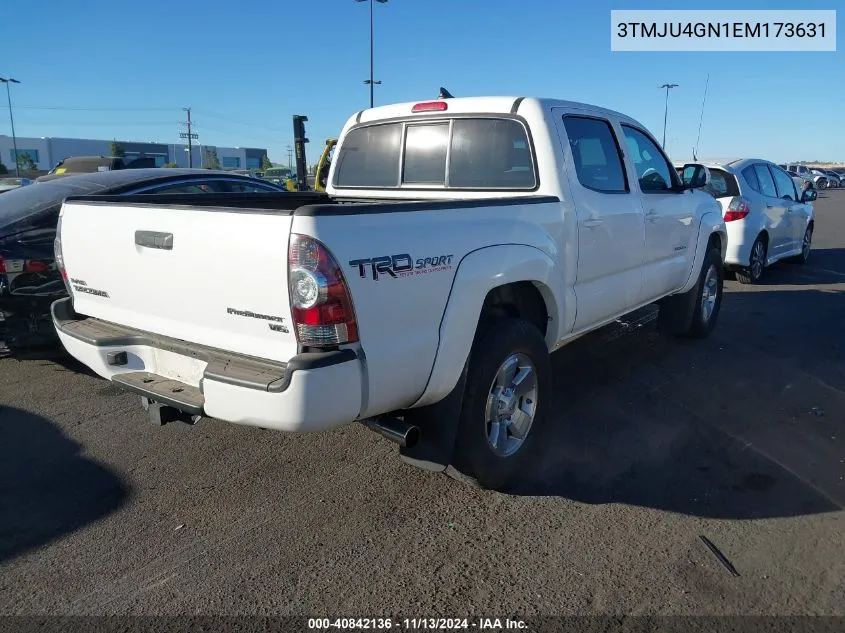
[0, 168, 284, 346]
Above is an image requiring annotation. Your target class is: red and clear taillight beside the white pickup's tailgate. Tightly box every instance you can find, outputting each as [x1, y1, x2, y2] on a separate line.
[288, 234, 358, 347]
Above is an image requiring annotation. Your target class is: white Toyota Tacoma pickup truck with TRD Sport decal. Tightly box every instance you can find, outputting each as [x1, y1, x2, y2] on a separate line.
[53, 97, 727, 489]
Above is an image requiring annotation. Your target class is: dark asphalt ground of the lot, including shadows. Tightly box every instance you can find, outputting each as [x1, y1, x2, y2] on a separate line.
[0, 190, 845, 617]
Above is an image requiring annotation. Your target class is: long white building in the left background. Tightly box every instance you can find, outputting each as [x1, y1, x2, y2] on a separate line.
[0, 135, 267, 172]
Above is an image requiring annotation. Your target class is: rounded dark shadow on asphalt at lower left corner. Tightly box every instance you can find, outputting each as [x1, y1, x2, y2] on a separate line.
[0, 407, 129, 563]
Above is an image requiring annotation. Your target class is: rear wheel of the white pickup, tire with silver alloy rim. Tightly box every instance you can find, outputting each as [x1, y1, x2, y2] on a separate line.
[456, 318, 552, 491]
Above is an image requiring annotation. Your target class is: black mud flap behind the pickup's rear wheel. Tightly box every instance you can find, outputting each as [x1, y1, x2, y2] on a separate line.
[399, 365, 467, 479]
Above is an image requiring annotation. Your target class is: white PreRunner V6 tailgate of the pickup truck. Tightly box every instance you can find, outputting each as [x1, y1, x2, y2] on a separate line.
[60, 201, 297, 362]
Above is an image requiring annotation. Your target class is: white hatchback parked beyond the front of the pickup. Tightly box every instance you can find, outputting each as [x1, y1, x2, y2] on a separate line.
[684, 158, 817, 284]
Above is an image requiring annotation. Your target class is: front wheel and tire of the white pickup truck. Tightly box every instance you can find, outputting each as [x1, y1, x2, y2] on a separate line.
[657, 247, 725, 338]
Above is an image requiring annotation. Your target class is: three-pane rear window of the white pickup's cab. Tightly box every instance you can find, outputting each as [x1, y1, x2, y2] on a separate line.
[332, 118, 537, 190]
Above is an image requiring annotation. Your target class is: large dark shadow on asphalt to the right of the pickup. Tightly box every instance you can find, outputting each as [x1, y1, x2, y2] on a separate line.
[512, 289, 845, 519]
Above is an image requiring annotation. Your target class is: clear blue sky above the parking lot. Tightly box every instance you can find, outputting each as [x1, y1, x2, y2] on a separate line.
[0, 0, 845, 163]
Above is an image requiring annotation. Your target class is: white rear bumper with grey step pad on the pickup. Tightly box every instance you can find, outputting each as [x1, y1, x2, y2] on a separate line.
[51, 297, 362, 432]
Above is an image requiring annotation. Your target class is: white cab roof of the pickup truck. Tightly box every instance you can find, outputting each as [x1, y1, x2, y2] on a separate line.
[353, 96, 639, 124]
